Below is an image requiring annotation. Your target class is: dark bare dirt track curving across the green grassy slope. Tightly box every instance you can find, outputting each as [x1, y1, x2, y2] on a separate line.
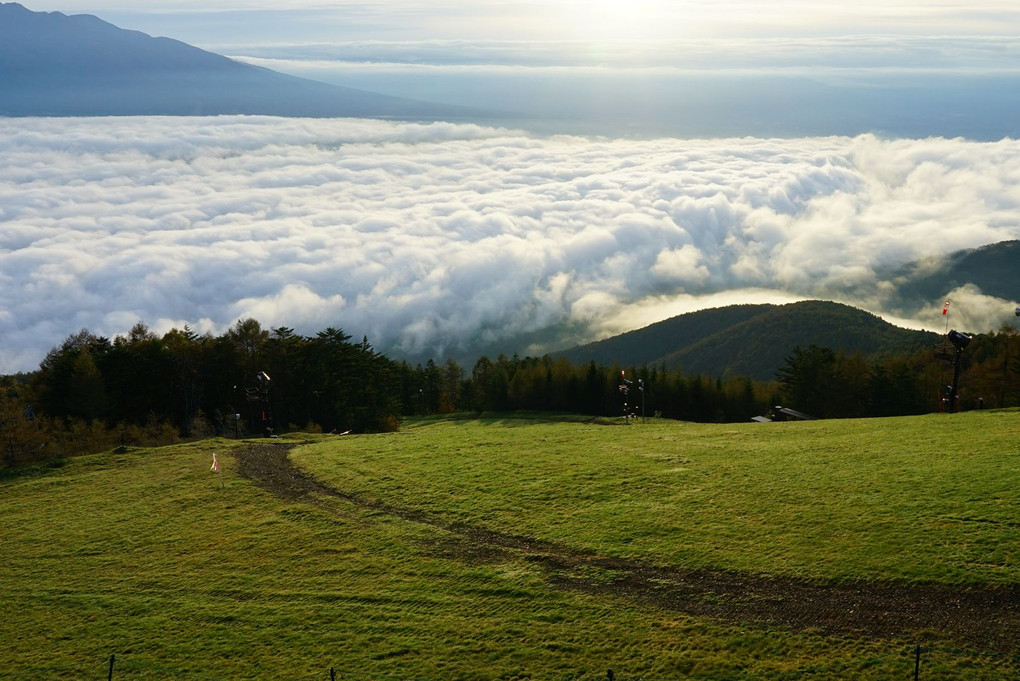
[237, 443, 1020, 654]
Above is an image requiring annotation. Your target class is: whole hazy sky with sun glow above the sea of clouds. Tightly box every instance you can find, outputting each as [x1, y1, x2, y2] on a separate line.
[19, 0, 1020, 141]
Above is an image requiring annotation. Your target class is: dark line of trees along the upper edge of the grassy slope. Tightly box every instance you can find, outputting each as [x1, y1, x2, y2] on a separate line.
[0, 319, 1020, 464]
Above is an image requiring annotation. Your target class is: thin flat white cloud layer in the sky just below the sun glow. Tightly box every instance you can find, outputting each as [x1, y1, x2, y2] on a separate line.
[229, 35, 1020, 72]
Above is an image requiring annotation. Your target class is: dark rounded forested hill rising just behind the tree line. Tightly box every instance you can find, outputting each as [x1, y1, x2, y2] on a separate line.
[556, 301, 937, 380]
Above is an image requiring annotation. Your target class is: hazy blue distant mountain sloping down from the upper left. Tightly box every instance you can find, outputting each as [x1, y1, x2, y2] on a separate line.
[0, 3, 477, 120]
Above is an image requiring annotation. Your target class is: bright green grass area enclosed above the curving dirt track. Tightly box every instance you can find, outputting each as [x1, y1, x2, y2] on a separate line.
[295, 412, 1020, 584]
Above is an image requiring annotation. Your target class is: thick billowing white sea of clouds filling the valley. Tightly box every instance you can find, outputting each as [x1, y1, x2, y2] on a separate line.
[0, 116, 1020, 373]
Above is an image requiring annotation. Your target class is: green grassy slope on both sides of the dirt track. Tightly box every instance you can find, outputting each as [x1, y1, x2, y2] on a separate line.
[0, 412, 1020, 679]
